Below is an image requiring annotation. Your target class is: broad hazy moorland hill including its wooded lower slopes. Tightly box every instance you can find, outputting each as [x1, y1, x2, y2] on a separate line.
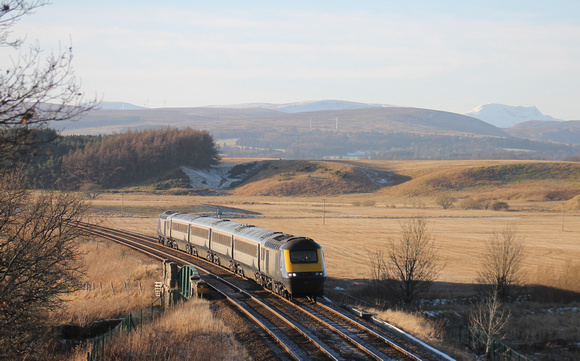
[54, 101, 579, 160]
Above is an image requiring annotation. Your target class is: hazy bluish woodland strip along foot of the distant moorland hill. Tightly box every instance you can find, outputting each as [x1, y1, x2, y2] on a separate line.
[219, 129, 580, 160]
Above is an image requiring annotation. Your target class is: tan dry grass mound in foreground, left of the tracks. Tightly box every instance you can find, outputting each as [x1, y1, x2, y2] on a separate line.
[66, 300, 248, 361]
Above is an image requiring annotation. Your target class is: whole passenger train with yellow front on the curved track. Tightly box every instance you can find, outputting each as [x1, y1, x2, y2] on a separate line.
[157, 211, 326, 300]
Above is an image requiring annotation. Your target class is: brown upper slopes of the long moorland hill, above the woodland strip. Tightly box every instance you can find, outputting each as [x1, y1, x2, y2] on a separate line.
[53, 106, 509, 138]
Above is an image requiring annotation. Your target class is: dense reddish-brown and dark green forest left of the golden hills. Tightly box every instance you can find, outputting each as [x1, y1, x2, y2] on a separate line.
[25, 128, 220, 190]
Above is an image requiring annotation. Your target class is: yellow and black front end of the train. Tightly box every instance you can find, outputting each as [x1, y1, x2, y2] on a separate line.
[280, 238, 326, 297]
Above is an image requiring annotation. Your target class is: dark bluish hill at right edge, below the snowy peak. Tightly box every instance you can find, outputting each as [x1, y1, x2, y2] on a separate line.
[505, 120, 580, 144]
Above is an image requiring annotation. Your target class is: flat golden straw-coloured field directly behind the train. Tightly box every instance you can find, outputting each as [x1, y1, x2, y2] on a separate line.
[92, 161, 580, 292]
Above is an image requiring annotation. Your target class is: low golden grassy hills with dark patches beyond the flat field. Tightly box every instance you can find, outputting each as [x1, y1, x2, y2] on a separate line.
[180, 160, 580, 201]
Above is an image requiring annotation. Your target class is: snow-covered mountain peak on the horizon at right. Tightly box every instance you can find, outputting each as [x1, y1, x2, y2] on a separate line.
[464, 104, 560, 128]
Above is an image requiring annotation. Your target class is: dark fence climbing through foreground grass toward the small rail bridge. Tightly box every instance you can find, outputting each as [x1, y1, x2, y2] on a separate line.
[87, 297, 165, 361]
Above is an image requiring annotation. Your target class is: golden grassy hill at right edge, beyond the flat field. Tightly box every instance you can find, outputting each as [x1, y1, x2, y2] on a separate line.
[342, 160, 580, 201]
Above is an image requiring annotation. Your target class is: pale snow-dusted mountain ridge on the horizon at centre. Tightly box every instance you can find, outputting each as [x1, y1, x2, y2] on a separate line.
[206, 100, 392, 113]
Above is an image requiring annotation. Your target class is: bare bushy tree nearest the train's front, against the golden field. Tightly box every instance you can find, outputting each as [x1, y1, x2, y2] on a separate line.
[369, 218, 442, 303]
